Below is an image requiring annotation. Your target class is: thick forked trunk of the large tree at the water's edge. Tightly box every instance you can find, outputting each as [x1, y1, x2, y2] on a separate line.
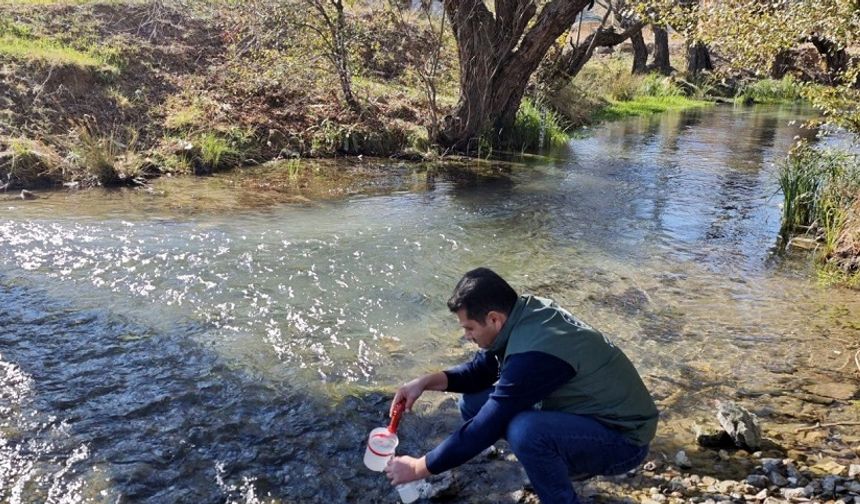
[437, 0, 589, 152]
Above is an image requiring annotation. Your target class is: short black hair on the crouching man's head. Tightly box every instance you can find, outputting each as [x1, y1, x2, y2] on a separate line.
[448, 268, 518, 324]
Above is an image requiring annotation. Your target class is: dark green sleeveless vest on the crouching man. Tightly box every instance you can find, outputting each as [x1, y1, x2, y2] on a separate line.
[489, 296, 658, 446]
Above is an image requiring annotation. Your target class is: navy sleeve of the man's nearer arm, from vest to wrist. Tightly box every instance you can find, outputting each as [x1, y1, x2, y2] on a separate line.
[426, 352, 576, 474]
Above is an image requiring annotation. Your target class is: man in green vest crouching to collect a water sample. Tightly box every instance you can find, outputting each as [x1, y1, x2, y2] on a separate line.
[385, 268, 658, 503]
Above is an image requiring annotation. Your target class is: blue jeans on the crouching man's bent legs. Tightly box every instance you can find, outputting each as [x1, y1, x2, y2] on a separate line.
[460, 388, 648, 504]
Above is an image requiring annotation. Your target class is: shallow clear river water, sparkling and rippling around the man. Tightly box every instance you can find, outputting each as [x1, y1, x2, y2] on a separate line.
[0, 107, 860, 503]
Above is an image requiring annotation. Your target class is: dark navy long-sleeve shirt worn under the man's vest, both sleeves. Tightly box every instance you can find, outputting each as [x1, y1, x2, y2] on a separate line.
[426, 352, 576, 474]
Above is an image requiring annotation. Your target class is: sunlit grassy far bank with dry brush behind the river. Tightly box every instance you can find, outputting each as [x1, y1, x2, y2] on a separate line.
[0, 0, 720, 190]
